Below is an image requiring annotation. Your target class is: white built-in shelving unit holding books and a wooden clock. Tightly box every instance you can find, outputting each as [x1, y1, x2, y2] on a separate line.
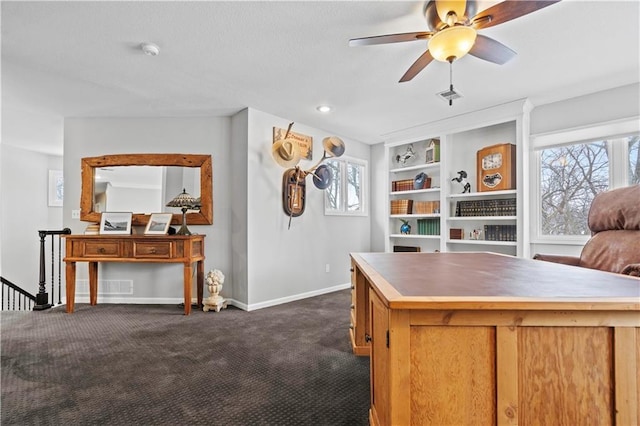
[385, 101, 530, 257]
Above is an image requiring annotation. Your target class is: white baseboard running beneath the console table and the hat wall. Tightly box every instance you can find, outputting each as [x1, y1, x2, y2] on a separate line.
[69, 283, 351, 311]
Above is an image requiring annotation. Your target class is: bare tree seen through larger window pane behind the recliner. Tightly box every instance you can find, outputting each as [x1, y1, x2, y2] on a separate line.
[540, 141, 609, 235]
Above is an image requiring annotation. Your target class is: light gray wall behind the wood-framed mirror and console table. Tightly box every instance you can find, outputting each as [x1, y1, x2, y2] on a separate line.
[64, 117, 233, 303]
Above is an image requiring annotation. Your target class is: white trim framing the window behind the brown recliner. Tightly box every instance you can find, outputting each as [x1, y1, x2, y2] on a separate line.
[530, 117, 640, 245]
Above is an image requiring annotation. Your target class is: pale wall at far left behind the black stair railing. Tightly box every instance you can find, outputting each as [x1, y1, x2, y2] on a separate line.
[0, 144, 63, 294]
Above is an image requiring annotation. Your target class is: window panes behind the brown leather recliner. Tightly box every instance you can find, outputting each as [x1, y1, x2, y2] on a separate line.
[537, 134, 640, 239]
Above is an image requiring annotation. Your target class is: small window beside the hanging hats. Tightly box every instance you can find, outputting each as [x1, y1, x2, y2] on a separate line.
[324, 158, 367, 216]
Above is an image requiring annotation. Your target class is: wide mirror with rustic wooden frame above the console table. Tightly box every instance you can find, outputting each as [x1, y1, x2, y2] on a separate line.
[80, 154, 213, 226]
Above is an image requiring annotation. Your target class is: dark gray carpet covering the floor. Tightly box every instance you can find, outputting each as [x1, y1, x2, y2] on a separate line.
[1, 290, 369, 425]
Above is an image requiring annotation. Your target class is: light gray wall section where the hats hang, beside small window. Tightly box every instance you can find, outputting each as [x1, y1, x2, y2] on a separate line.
[247, 109, 370, 308]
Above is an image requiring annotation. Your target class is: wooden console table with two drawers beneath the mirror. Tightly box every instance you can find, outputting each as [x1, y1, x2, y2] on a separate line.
[63, 235, 205, 315]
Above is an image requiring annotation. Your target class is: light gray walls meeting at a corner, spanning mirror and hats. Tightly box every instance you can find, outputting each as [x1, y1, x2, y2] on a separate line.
[64, 114, 370, 310]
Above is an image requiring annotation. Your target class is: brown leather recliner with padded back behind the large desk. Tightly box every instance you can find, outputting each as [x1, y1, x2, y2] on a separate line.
[533, 185, 640, 277]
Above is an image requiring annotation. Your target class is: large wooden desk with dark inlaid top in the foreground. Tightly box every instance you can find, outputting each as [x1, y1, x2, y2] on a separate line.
[351, 253, 640, 426]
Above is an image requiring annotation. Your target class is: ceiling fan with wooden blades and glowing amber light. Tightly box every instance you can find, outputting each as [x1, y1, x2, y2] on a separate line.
[349, 0, 560, 83]
